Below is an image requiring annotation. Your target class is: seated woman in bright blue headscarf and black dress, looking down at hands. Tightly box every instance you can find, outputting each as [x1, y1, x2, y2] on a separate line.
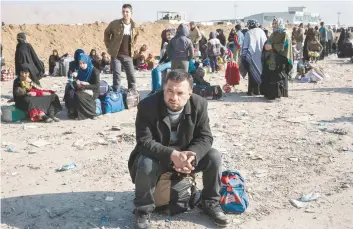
[64, 54, 100, 120]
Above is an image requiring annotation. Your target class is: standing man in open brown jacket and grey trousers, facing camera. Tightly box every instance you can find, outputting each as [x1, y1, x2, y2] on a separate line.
[104, 4, 139, 91]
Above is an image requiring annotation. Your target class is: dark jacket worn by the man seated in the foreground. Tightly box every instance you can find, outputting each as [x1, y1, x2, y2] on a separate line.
[129, 91, 213, 179]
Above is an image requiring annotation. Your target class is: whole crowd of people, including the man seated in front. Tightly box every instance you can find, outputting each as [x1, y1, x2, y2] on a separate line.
[7, 4, 349, 229]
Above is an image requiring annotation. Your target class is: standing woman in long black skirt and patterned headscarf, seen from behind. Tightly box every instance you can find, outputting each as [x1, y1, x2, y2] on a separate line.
[260, 18, 293, 100]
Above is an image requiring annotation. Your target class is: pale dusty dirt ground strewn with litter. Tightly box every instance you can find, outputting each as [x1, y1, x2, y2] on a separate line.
[1, 56, 353, 229]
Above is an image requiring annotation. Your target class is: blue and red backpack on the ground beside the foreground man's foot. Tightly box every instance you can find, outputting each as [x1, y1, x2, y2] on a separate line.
[219, 171, 249, 214]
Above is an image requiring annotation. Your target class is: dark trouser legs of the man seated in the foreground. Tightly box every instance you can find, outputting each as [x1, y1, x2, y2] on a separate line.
[131, 149, 222, 214]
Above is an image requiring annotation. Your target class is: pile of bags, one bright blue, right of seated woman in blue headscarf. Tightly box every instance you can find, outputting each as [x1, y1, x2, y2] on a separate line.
[96, 80, 140, 115]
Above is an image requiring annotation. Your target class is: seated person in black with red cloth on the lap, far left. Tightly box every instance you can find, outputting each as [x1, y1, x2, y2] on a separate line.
[13, 64, 62, 122]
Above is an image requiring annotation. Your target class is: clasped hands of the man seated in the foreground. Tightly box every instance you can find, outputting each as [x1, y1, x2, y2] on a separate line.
[171, 151, 196, 174]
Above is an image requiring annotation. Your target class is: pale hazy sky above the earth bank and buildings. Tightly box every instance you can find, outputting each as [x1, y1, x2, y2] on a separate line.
[1, 0, 353, 24]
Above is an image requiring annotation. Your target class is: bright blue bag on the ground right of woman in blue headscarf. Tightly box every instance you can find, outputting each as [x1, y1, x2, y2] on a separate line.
[101, 91, 125, 114]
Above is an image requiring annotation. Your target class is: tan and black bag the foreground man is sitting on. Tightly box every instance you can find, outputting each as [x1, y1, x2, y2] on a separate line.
[153, 172, 196, 216]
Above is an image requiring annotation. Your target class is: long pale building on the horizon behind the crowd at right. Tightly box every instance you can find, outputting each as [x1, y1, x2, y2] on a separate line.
[244, 7, 321, 26]
